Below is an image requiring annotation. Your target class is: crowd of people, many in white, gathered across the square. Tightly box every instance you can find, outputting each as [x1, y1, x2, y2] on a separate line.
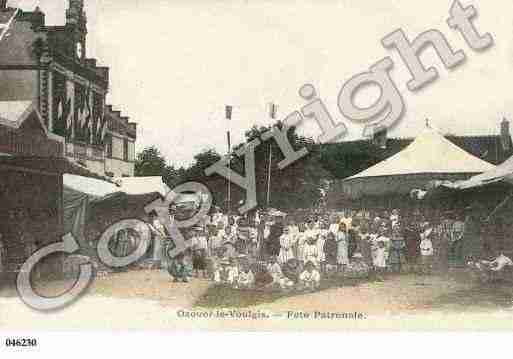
[147, 209, 512, 290]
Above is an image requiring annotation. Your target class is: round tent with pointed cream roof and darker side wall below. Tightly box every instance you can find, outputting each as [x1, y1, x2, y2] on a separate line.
[342, 128, 495, 198]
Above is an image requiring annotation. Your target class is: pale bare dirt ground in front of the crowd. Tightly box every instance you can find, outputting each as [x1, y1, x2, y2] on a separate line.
[0, 270, 513, 329]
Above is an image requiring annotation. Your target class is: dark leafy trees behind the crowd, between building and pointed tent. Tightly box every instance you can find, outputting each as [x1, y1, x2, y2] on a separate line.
[136, 122, 330, 211]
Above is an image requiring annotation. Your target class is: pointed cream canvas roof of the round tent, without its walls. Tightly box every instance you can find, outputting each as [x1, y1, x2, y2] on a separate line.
[346, 128, 495, 180]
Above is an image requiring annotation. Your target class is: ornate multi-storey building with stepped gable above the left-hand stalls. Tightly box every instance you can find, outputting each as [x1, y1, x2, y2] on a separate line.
[0, 0, 137, 177]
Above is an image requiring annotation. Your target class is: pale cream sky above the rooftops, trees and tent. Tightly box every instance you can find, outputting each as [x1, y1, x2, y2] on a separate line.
[9, 0, 513, 165]
